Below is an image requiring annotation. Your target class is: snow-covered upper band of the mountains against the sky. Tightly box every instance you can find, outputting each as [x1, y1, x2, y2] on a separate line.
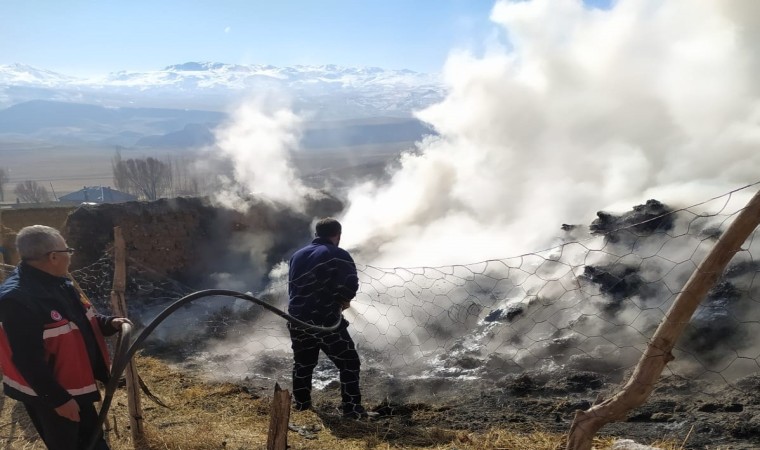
[0, 62, 444, 119]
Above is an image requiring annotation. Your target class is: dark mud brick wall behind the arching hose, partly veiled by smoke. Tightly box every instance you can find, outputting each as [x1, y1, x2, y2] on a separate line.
[63, 194, 343, 286]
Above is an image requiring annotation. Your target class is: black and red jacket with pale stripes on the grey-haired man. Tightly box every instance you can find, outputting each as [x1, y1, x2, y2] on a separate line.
[0, 262, 118, 408]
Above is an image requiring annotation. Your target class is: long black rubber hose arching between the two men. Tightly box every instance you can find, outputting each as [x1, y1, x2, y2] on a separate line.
[87, 289, 342, 450]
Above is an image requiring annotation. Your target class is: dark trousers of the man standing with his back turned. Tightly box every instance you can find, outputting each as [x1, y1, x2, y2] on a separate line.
[288, 324, 362, 413]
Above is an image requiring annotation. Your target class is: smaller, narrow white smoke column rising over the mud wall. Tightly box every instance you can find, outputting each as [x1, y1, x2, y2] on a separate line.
[198, 98, 320, 298]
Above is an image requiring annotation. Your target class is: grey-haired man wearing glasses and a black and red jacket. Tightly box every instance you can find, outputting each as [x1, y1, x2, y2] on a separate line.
[0, 225, 129, 450]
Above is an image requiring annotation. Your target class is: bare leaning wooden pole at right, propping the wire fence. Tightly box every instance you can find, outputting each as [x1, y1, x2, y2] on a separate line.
[566, 192, 760, 450]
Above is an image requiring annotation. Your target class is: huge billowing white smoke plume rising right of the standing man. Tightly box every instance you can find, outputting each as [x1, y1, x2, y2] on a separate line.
[343, 0, 760, 267]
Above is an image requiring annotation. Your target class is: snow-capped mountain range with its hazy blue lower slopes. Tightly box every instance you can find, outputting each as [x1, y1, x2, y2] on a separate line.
[0, 62, 445, 148]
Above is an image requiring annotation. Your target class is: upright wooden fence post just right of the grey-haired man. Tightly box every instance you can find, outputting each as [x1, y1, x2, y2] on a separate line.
[111, 227, 145, 449]
